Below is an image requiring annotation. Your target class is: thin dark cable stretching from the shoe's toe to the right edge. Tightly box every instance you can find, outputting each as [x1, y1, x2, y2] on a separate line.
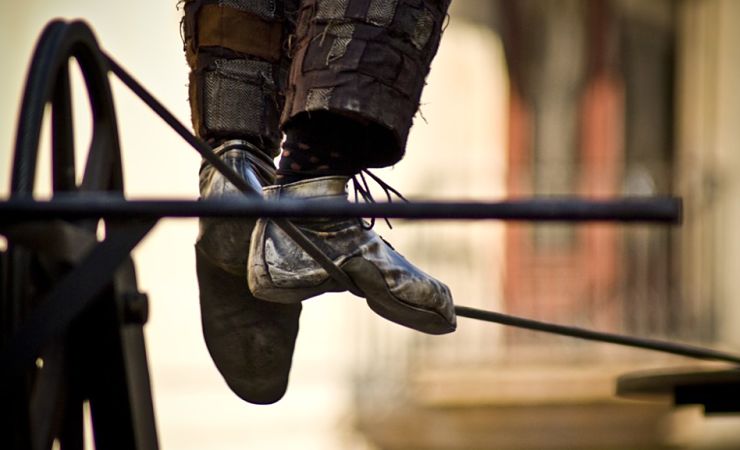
[455, 306, 740, 364]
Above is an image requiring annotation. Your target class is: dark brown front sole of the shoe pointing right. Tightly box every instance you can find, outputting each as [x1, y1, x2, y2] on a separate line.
[342, 258, 457, 334]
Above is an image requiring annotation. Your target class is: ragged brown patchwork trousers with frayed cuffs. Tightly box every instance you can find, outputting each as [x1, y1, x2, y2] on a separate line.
[183, 0, 450, 167]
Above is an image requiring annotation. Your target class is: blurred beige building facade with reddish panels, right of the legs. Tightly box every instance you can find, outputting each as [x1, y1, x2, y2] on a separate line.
[355, 0, 740, 449]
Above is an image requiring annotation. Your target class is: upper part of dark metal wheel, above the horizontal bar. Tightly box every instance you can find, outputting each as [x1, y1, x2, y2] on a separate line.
[11, 20, 123, 196]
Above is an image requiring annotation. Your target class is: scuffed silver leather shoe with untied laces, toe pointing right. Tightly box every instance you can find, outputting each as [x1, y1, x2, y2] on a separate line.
[247, 176, 456, 334]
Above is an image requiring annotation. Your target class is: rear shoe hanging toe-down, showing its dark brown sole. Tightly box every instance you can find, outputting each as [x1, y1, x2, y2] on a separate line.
[195, 140, 301, 404]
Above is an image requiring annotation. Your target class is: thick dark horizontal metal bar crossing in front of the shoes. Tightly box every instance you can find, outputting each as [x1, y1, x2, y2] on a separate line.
[0, 194, 681, 224]
